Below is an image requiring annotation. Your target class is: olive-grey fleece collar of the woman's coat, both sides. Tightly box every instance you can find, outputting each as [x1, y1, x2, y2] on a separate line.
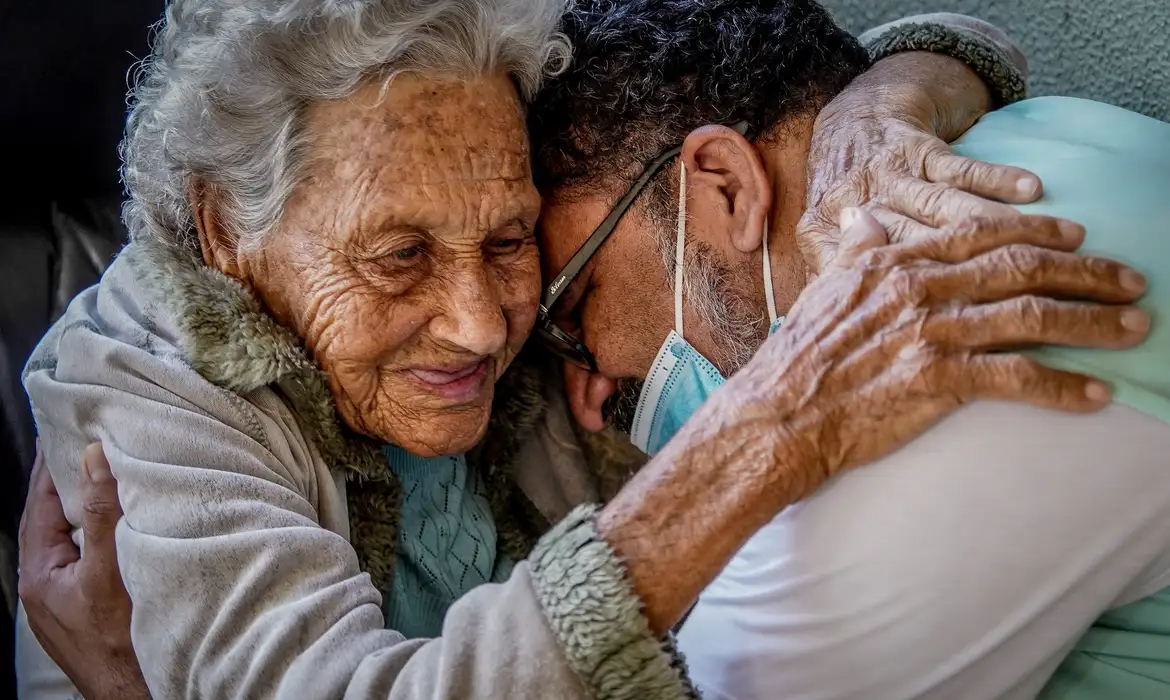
[123, 239, 549, 591]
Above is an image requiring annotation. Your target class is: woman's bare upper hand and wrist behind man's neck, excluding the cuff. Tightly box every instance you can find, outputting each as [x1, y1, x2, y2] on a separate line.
[797, 53, 1041, 274]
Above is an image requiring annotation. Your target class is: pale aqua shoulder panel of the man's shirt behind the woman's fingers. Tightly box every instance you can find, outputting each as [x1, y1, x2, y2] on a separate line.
[954, 97, 1170, 423]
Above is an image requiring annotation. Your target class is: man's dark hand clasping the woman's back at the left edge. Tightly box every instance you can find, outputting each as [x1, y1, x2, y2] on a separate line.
[19, 445, 150, 700]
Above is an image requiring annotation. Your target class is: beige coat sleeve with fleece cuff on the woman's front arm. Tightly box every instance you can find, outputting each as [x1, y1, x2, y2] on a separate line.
[26, 286, 694, 700]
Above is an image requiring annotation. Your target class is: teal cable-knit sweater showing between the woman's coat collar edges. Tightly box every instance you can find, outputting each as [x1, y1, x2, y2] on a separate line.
[383, 446, 511, 638]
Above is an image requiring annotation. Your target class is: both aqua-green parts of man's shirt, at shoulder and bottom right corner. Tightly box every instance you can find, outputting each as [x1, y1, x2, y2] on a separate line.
[955, 97, 1170, 700]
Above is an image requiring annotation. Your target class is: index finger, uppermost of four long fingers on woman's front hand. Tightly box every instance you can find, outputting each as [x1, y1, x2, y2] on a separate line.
[890, 213, 1085, 263]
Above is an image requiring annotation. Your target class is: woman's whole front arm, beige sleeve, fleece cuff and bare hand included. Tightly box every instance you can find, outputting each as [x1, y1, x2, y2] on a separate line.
[18, 208, 1143, 700]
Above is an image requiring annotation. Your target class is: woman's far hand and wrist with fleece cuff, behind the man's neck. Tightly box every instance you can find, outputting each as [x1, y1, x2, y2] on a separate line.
[798, 13, 1041, 270]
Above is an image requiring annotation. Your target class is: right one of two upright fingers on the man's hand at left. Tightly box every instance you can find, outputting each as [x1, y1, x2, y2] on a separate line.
[81, 442, 122, 586]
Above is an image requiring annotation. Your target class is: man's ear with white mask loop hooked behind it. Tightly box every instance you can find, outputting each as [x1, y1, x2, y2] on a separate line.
[681, 124, 772, 253]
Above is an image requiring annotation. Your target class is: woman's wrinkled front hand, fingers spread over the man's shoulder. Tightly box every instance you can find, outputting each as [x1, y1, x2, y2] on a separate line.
[714, 210, 1149, 505]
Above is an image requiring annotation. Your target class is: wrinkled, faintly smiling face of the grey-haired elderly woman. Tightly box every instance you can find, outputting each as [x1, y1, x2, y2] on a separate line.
[240, 75, 541, 455]
